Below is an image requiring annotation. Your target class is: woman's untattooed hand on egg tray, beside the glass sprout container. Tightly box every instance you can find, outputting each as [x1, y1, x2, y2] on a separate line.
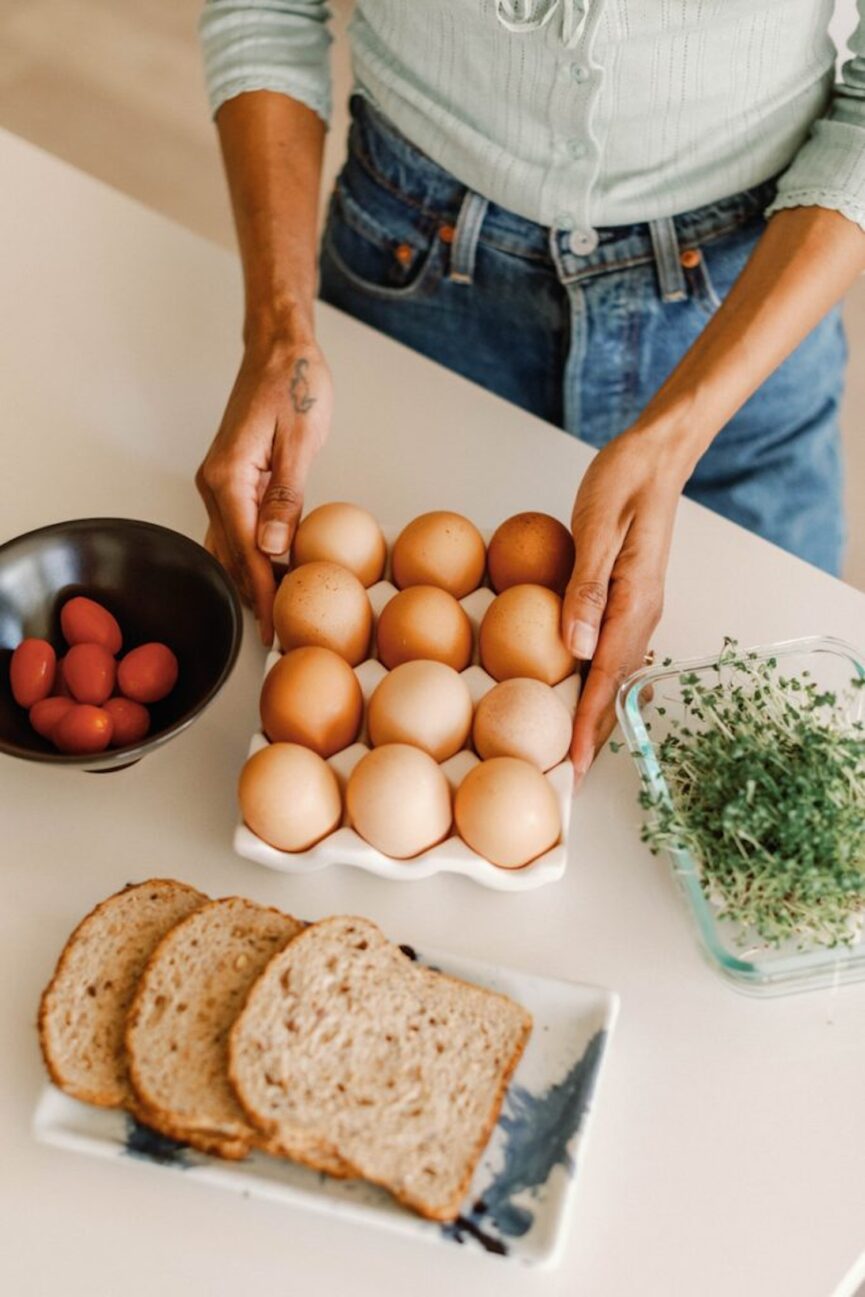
[562, 427, 691, 782]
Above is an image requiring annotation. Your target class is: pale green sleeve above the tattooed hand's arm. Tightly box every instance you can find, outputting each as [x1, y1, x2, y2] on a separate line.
[198, 0, 332, 125]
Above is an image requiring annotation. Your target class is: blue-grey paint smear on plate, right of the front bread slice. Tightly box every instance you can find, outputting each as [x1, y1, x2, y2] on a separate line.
[442, 1031, 607, 1255]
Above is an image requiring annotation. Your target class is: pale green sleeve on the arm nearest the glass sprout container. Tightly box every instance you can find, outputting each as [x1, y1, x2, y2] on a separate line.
[766, 0, 865, 230]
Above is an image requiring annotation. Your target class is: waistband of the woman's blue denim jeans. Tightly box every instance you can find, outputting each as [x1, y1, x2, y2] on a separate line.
[350, 93, 776, 278]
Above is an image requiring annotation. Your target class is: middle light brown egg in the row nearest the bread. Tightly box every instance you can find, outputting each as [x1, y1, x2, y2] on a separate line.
[345, 743, 451, 860]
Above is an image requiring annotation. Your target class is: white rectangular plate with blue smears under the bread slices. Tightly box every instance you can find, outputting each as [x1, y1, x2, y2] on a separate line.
[34, 947, 619, 1266]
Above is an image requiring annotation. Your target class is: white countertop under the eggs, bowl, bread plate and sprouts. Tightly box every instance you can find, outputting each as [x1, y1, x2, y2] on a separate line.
[0, 134, 865, 1297]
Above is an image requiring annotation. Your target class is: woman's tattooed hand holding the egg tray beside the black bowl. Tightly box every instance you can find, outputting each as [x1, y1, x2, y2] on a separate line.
[196, 342, 333, 645]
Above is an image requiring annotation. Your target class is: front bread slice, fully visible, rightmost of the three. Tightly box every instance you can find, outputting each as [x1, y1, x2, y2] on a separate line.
[228, 917, 532, 1220]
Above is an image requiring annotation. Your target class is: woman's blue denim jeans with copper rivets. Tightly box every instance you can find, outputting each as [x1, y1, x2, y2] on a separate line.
[320, 96, 846, 572]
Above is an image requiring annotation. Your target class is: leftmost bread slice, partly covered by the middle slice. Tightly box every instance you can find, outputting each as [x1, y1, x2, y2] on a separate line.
[39, 878, 207, 1105]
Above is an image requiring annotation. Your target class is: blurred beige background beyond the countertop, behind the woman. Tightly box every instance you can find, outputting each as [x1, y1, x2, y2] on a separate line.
[0, 0, 865, 588]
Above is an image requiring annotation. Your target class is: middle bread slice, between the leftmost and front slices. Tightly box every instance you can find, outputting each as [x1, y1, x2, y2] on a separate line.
[126, 896, 305, 1160]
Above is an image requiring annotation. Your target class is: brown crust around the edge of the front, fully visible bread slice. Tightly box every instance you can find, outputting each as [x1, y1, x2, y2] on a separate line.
[228, 916, 532, 1222]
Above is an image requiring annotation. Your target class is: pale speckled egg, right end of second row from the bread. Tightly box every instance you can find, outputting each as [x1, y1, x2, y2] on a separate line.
[472, 677, 572, 770]
